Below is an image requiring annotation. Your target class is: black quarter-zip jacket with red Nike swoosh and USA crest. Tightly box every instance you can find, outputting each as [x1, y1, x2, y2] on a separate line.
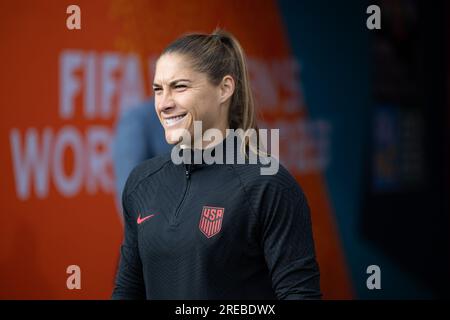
[112, 134, 321, 299]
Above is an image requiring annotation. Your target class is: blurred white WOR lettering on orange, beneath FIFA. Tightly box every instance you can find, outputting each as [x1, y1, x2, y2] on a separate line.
[10, 125, 114, 200]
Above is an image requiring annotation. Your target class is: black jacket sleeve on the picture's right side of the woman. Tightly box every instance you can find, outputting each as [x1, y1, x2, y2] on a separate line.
[262, 187, 321, 300]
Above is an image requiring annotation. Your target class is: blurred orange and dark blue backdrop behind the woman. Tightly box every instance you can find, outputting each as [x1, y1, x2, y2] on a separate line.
[0, 0, 450, 299]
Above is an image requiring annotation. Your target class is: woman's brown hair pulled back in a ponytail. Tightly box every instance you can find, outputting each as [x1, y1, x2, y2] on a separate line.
[161, 29, 258, 131]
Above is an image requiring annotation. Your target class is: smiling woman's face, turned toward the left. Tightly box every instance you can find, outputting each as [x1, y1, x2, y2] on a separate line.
[153, 53, 228, 144]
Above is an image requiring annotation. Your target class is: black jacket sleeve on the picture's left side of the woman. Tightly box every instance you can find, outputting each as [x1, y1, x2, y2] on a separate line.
[112, 187, 145, 300]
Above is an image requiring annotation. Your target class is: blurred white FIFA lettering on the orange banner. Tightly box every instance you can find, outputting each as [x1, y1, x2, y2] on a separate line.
[59, 50, 144, 119]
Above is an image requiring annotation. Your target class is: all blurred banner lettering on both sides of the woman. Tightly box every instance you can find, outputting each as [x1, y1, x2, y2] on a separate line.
[9, 49, 331, 200]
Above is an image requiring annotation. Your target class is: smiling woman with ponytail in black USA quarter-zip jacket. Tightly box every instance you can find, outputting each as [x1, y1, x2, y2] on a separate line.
[112, 30, 321, 299]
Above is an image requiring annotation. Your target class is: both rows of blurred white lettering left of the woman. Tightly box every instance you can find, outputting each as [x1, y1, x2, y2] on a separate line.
[10, 50, 144, 200]
